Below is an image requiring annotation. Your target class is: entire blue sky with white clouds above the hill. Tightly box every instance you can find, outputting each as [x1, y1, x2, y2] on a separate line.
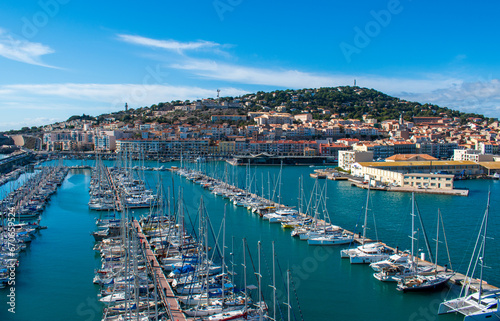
[0, 0, 500, 130]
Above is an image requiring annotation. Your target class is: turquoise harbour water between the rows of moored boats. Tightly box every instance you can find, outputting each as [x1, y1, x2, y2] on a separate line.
[0, 162, 500, 321]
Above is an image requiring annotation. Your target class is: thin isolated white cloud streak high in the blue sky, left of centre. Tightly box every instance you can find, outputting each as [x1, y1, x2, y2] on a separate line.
[118, 34, 221, 53]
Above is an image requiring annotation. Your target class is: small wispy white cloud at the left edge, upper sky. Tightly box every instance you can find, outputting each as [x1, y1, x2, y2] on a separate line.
[0, 29, 56, 68]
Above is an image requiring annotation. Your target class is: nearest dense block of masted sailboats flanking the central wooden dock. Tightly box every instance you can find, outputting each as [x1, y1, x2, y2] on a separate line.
[89, 160, 300, 320]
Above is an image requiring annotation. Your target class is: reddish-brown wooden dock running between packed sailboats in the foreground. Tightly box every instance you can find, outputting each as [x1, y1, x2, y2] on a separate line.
[133, 220, 193, 321]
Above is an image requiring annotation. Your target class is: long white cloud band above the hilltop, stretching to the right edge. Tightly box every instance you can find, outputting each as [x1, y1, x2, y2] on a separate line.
[170, 59, 500, 118]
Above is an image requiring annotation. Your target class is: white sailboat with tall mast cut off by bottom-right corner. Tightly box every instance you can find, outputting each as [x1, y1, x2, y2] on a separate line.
[438, 193, 500, 321]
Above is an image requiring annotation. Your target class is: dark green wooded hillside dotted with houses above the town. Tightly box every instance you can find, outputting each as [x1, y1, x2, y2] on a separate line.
[0, 86, 491, 134]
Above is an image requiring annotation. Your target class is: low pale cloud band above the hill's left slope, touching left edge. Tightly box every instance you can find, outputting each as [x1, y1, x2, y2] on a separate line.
[0, 83, 247, 130]
